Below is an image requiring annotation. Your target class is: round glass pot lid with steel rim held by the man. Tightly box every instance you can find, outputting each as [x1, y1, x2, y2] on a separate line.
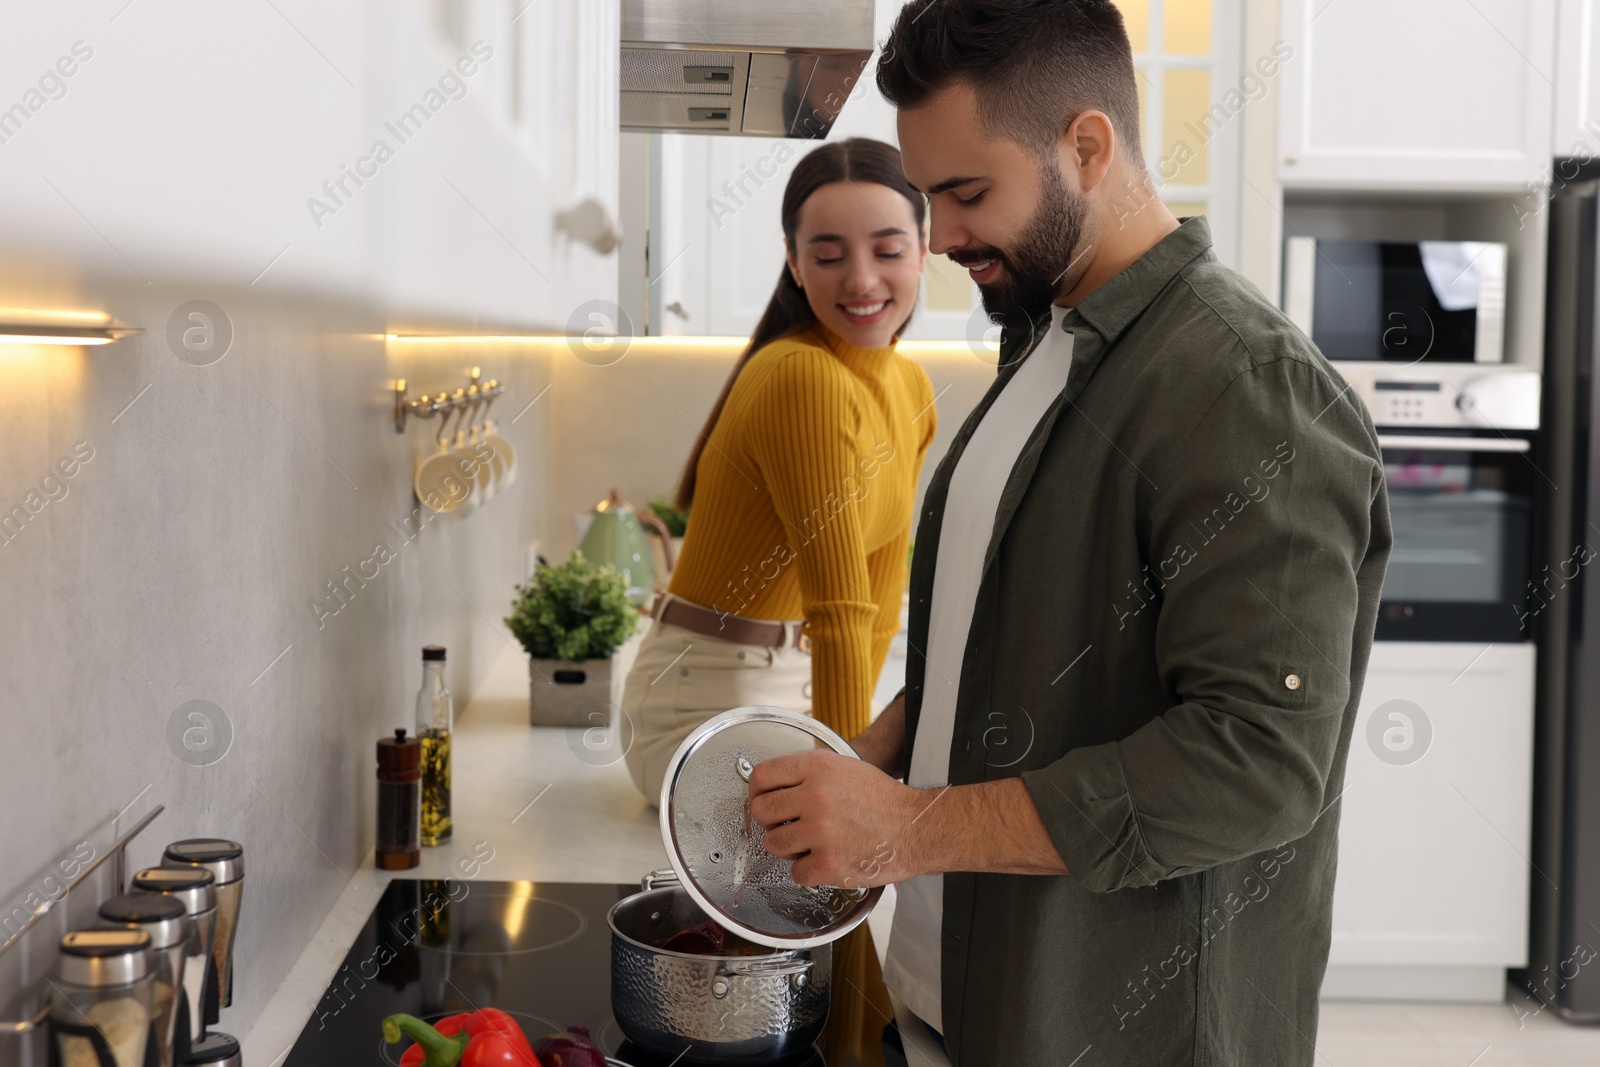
[661, 704, 883, 949]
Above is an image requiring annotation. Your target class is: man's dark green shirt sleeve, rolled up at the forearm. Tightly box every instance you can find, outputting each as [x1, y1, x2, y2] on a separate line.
[1022, 358, 1382, 891]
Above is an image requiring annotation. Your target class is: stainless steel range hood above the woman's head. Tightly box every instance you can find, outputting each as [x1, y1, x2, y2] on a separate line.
[621, 0, 874, 139]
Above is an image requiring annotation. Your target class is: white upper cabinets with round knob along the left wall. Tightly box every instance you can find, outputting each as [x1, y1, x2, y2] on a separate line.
[0, 0, 621, 333]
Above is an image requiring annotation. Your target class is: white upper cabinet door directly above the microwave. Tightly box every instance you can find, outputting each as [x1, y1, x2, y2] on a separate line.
[1278, 0, 1555, 190]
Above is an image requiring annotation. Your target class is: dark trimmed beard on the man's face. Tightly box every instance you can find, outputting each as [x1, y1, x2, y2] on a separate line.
[960, 160, 1088, 350]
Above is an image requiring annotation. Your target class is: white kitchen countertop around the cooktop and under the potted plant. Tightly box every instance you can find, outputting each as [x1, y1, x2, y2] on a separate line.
[244, 617, 904, 1067]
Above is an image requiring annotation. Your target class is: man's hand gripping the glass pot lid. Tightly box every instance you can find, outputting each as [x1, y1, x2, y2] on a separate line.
[750, 752, 938, 888]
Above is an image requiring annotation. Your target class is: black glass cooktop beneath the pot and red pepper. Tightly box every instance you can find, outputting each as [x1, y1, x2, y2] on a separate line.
[283, 878, 826, 1067]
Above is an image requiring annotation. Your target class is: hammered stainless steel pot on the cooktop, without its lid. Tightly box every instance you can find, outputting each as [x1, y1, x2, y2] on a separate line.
[606, 869, 834, 1065]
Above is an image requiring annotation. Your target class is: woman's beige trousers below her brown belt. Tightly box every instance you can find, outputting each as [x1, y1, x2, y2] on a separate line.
[622, 591, 811, 806]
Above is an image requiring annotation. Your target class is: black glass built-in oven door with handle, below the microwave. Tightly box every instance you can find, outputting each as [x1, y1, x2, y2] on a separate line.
[1376, 429, 1539, 645]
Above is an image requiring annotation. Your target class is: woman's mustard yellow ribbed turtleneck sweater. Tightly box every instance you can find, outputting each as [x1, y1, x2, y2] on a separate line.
[669, 316, 938, 739]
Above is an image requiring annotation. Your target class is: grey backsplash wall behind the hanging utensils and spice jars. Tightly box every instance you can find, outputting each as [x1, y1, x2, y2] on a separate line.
[0, 283, 556, 1036]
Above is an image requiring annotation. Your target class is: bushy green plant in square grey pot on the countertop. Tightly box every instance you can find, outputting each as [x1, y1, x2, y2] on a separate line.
[506, 549, 638, 726]
